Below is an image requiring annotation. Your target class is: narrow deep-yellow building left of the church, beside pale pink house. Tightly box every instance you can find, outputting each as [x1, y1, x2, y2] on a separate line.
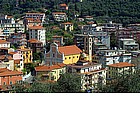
[17, 46, 33, 64]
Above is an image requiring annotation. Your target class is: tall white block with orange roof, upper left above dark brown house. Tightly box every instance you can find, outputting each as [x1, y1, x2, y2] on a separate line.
[29, 26, 46, 46]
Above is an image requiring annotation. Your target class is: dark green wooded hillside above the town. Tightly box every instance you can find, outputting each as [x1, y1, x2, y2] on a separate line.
[0, 0, 140, 24]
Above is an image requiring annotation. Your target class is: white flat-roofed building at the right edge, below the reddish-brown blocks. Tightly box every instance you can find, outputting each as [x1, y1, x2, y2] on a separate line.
[119, 38, 139, 51]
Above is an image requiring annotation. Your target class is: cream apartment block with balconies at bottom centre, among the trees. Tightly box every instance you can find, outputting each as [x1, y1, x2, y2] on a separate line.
[67, 55, 106, 91]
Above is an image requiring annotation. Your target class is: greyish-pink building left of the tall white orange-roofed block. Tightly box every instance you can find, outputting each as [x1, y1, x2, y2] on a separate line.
[7, 33, 27, 46]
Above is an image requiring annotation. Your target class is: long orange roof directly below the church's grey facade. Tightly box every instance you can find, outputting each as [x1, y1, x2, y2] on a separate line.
[35, 63, 66, 72]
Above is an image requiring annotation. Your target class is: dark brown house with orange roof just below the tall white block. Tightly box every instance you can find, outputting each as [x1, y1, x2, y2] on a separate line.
[28, 39, 43, 53]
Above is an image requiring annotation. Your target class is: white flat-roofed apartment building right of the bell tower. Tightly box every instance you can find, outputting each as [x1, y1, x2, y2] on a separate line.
[93, 50, 131, 68]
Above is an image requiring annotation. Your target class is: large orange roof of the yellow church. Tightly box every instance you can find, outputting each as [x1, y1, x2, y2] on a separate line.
[58, 45, 82, 55]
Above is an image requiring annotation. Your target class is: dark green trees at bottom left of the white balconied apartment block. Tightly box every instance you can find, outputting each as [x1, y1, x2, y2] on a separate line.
[13, 73, 81, 93]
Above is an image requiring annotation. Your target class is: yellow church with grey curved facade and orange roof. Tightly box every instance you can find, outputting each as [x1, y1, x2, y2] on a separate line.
[46, 43, 82, 65]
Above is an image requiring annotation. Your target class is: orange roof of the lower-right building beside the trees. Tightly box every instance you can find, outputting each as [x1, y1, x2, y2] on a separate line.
[108, 62, 135, 68]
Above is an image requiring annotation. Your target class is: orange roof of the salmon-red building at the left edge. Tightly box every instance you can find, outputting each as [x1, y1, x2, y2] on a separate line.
[0, 70, 23, 77]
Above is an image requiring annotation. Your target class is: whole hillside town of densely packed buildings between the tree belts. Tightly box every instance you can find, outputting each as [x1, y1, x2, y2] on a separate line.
[0, 1, 140, 92]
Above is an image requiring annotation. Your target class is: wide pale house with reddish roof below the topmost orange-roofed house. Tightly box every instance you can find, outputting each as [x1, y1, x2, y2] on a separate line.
[52, 12, 68, 22]
